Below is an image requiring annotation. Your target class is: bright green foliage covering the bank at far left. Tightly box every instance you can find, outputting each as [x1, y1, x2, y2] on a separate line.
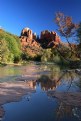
[0, 30, 21, 62]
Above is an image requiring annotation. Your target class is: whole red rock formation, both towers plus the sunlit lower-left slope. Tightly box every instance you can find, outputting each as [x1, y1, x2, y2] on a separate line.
[20, 28, 61, 58]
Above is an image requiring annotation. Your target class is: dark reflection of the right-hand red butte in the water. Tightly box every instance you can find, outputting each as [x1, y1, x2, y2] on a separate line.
[37, 72, 66, 90]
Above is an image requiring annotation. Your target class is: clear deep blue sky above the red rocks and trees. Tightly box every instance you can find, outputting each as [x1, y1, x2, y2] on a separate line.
[0, 0, 81, 36]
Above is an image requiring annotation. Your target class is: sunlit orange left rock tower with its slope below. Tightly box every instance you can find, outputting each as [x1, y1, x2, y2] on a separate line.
[20, 28, 41, 58]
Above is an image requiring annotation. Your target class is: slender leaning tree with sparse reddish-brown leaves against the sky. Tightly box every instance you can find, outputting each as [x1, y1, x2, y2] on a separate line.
[55, 12, 78, 57]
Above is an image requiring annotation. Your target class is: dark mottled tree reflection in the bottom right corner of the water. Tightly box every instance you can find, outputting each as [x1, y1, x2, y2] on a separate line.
[56, 102, 81, 121]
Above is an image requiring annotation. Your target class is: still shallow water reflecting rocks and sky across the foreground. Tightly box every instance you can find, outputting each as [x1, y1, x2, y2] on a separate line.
[0, 63, 81, 121]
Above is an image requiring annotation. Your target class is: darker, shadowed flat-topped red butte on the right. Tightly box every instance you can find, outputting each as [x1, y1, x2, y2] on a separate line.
[40, 30, 61, 48]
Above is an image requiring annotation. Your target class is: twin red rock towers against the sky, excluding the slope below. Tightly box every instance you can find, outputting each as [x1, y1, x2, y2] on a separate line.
[20, 28, 61, 50]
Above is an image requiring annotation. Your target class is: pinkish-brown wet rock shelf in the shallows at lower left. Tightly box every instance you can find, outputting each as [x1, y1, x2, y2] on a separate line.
[0, 81, 35, 117]
